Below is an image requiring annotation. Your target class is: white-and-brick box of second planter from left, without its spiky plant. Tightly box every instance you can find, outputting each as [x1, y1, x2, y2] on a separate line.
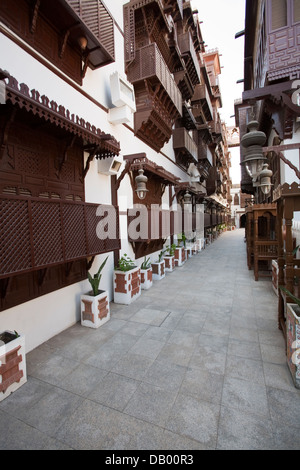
[81, 291, 110, 328]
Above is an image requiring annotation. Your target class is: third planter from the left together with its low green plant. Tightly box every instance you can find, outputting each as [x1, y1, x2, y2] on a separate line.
[114, 253, 141, 305]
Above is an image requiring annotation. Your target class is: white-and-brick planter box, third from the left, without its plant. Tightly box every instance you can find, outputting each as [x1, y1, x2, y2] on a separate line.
[114, 267, 141, 305]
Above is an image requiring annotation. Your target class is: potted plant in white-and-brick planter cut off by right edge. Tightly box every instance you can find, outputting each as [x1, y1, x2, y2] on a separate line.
[279, 286, 300, 388]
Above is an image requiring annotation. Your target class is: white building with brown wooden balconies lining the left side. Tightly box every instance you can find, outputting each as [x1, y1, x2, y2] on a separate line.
[0, 0, 231, 352]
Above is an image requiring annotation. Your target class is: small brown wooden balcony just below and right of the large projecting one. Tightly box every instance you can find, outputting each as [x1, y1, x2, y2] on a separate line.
[173, 127, 198, 165]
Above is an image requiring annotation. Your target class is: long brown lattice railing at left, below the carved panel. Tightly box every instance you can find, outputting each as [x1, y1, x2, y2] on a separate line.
[0, 196, 120, 279]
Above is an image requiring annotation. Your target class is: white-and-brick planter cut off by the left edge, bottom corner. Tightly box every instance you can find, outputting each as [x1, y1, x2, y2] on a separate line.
[0, 330, 27, 401]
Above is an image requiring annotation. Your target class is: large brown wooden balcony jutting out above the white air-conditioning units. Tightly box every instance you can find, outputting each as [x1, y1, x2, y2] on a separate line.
[127, 43, 182, 151]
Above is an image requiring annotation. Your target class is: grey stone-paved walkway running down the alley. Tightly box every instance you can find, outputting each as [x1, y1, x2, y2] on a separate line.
[0, 230, 300, 450]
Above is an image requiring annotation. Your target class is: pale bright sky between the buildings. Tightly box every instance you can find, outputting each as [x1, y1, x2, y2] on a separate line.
[191, 0, 245, 184]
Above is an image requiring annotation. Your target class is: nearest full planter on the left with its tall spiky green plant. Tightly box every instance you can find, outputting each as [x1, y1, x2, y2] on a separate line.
[81, 257, 110, 328]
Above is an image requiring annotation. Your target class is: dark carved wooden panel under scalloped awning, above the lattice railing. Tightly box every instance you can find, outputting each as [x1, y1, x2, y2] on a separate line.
[0, 110, 84, 201]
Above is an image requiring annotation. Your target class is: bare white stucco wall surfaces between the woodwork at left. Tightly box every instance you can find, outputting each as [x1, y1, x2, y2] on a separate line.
[0, 0, 187, 352]
